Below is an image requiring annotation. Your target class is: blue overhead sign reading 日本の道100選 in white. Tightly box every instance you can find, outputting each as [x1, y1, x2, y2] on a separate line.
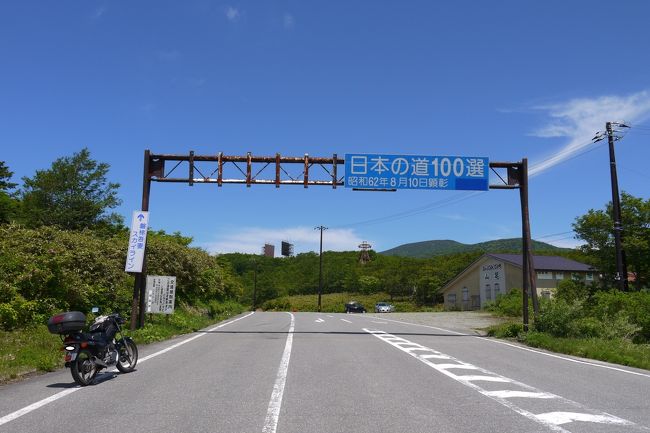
[344, 153, 490, 191]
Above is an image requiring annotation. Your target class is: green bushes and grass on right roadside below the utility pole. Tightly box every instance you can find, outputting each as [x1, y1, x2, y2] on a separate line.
[488, 281, 650, 370]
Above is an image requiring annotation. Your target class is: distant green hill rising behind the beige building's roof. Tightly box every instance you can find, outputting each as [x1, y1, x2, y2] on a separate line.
[379, 238, 569, 258]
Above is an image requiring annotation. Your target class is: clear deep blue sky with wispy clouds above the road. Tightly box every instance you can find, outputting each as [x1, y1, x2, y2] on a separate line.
[0, 0, 650, 252]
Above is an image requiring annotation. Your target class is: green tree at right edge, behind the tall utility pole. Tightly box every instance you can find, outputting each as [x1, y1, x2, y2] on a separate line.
[573, 192, 650, 290]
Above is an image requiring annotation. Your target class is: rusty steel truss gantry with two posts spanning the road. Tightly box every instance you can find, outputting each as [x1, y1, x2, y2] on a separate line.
[131, 150, 538, 330]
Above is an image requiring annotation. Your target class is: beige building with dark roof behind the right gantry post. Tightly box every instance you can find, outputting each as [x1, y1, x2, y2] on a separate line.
[440, 254, 597, 310]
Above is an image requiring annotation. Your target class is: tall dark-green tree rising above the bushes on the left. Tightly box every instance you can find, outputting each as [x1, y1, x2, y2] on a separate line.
[21, 148, 121, 230]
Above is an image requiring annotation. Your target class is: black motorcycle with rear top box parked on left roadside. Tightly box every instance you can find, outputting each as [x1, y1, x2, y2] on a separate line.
[47, 307, 138, 386]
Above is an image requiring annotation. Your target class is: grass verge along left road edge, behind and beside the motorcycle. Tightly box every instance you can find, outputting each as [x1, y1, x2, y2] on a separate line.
[0, 302, 244, 384]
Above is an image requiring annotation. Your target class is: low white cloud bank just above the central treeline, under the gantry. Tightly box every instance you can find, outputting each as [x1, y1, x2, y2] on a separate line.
[199, 227, 372, 255]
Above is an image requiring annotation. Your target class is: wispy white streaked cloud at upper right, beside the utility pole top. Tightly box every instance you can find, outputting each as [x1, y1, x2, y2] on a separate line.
[529, 91, 650, 177]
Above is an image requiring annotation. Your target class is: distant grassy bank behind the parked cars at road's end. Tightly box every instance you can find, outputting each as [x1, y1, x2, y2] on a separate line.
[262, 293, 440, 313]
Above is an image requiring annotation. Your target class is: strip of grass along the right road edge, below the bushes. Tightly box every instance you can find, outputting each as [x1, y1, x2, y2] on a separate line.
[487, 321, 650, 370]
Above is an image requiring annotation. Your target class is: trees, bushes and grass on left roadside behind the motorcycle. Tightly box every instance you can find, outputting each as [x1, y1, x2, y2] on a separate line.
[0, 149, 245, 383]
